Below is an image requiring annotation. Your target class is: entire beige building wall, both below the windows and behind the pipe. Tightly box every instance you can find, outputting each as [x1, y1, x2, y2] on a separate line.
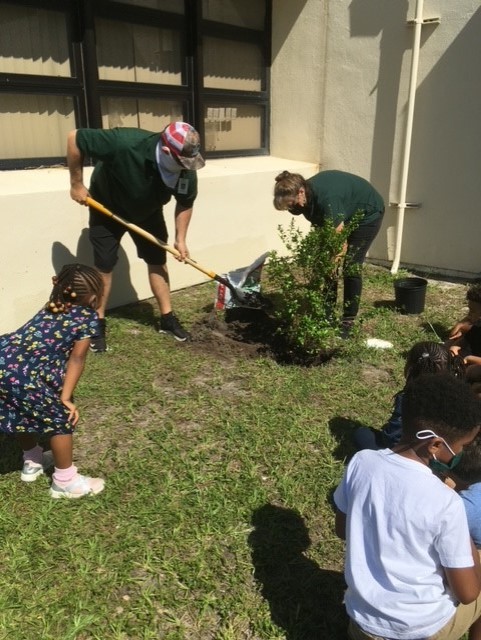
[0, 0, 481, 333]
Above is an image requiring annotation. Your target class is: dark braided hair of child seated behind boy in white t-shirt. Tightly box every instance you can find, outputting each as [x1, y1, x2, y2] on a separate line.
[404, 341, 466, 380]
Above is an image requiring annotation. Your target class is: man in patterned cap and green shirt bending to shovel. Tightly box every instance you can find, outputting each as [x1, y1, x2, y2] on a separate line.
[67, 122, 205, 353]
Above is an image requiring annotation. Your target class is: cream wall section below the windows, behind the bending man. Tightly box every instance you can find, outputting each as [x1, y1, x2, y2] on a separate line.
[0, 157, 316, 333]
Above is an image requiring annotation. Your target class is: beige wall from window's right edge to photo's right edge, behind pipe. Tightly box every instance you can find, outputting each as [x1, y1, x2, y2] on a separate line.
[271, 0, 481, 278]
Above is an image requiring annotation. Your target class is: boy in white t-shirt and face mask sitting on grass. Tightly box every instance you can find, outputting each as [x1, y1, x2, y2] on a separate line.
[334, 374, 481, 640]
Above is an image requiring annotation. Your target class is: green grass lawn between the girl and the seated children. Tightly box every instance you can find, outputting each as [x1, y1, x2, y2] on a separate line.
[0, 266, 465, 640]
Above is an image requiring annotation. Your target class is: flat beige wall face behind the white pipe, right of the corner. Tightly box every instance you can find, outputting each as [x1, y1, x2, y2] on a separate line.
[322, 0, 481, 275]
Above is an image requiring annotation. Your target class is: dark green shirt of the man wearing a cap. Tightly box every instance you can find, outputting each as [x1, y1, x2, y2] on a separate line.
[76, 127, 197, 222]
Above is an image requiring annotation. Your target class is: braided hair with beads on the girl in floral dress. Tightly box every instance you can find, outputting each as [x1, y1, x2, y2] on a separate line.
[45, 264, 104, 313]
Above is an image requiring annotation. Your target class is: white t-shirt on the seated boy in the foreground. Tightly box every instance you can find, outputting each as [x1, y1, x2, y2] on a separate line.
[334, 449, 473, 640]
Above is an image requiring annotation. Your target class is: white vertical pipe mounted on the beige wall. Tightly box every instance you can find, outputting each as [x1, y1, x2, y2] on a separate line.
[391, 0, 424, 274]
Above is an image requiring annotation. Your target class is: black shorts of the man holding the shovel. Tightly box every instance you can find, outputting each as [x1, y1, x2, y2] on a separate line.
[89, 209, 168, 273]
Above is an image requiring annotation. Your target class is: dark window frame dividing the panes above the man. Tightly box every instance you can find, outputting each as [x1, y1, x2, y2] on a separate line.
[0, 0, 272, 169]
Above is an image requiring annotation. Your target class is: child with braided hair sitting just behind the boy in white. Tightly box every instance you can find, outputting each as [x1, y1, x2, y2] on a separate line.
[354, 341, 465, 449]
